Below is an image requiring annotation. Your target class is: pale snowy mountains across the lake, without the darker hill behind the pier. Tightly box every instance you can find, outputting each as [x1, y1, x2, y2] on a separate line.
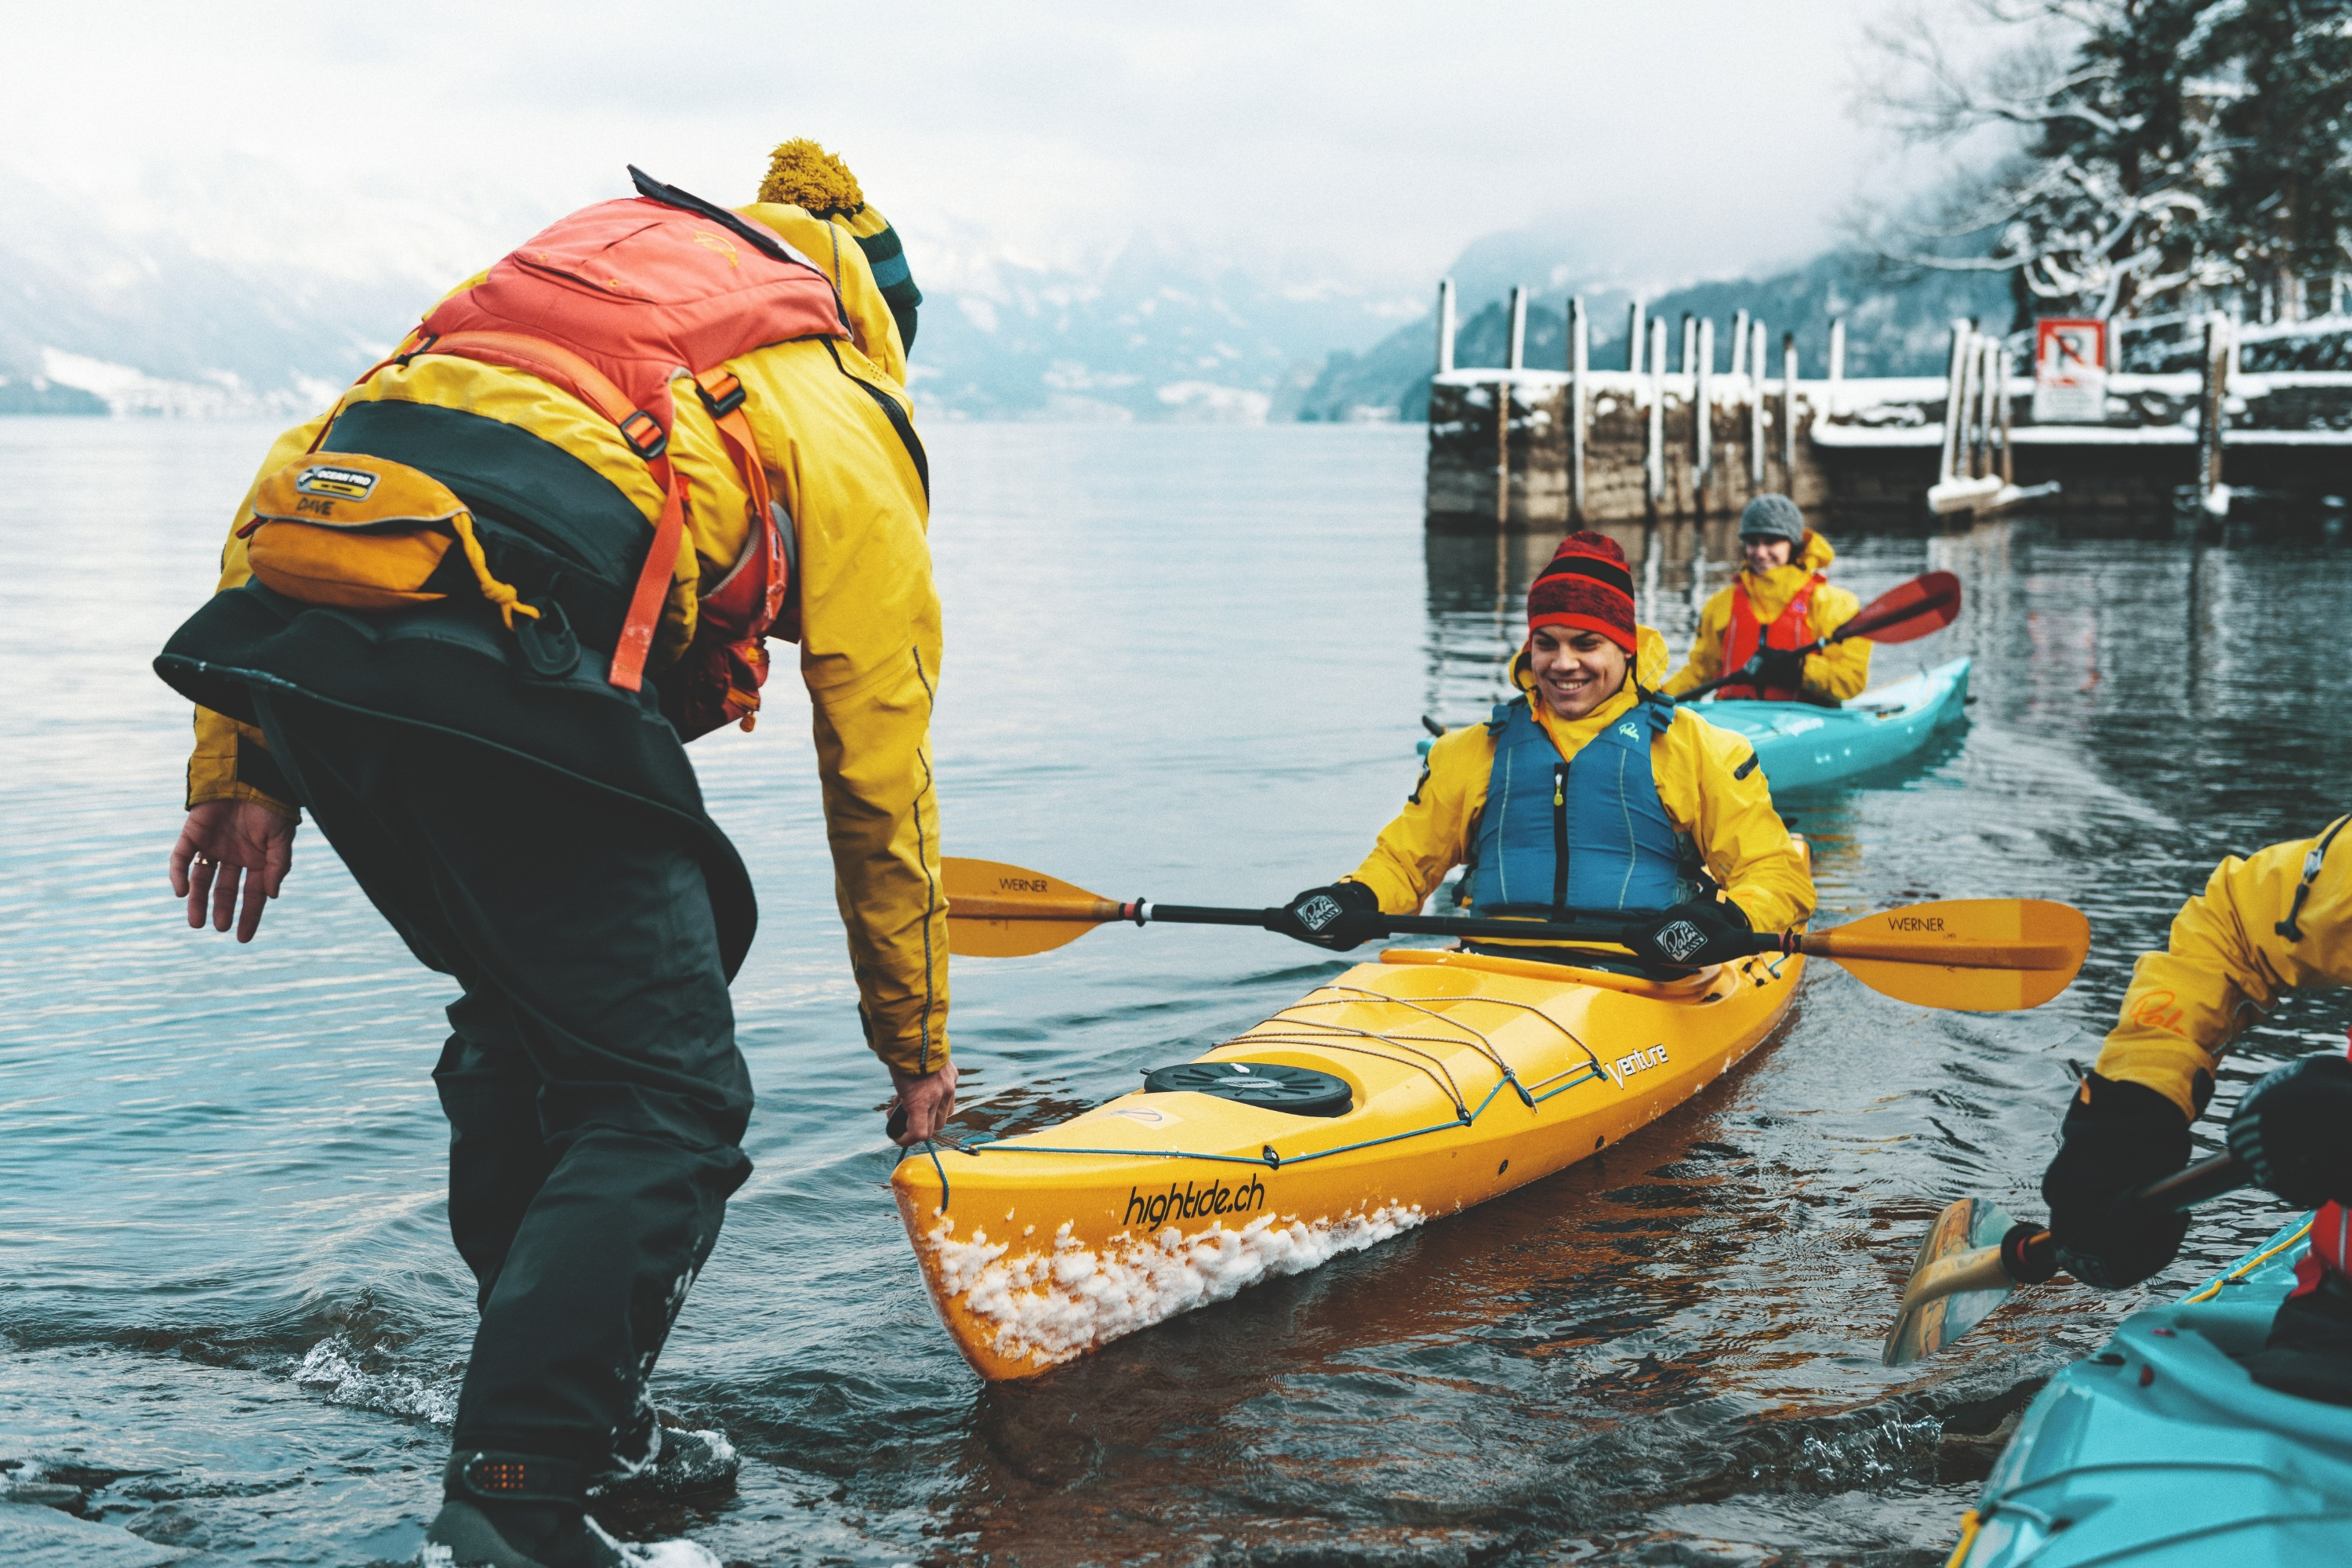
[0, 174, 1425, 423]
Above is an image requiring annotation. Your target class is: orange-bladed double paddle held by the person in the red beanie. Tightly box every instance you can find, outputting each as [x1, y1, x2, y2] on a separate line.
[941, 855, 2091, 1013]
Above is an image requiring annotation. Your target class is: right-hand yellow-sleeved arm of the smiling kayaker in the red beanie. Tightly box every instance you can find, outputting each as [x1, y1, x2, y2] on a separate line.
[1651, 710, 1813, 931]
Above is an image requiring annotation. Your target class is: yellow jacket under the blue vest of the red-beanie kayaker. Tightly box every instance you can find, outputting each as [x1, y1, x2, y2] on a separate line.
[1348, 626, 1813, 931]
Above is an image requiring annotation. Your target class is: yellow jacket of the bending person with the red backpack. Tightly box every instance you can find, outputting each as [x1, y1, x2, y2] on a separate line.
[188, 205, 948, 1072]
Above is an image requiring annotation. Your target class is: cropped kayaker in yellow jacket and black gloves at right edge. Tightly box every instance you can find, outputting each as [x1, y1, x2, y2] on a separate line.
[2042, 818, 2352, 1403]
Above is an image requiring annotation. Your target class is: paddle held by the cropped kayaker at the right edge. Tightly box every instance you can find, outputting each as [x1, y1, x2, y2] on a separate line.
[1879, 1154, 2253, 1366]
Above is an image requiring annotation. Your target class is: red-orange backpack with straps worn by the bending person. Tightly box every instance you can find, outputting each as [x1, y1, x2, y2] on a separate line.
[336, 167, 849, 739]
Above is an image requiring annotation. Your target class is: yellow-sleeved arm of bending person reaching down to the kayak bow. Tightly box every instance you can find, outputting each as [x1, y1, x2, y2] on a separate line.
[734, 343, 948, 1088]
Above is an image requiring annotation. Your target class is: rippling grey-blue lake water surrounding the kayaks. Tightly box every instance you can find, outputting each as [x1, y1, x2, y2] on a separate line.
[0, 419, 2352, 1566]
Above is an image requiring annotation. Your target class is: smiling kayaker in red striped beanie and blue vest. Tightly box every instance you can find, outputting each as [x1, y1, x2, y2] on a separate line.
[1284, 534, 1813, 968]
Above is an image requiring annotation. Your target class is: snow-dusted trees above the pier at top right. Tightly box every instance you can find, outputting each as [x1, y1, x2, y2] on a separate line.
[1872, 0, 2352, 325]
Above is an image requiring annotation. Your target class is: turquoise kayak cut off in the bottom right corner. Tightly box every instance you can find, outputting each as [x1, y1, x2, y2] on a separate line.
[1950, 1220, 2352, 1568]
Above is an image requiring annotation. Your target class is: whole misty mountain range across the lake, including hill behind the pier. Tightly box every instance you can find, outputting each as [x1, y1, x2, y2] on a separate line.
[0, 169, 2006, 423]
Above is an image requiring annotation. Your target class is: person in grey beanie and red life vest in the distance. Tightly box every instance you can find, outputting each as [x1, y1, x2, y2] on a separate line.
[1663, 496, 1870, 708]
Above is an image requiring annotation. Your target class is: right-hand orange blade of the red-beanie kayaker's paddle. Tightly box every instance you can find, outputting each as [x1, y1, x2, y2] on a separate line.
[1804, 898, 2091, 1013]
